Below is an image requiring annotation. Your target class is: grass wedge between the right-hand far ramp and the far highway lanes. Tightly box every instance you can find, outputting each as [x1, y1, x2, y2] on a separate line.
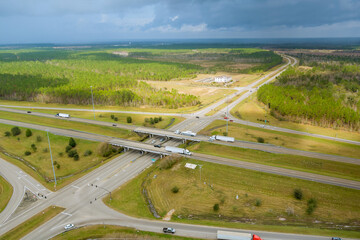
[199, 120, 360, 159]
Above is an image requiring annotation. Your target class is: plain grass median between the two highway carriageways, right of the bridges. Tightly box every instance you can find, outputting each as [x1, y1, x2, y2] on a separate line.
[188, 142, 360, 181]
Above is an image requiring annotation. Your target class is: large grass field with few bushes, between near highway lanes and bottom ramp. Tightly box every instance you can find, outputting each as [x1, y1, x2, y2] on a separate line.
[105, 159, 360, 237]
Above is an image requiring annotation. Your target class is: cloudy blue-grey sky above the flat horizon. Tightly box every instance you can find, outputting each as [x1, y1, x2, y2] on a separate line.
[0, 0, 360, 44]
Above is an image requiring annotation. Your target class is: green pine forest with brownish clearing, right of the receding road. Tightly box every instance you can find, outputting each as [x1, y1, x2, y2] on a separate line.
[257, 61, 360, 131]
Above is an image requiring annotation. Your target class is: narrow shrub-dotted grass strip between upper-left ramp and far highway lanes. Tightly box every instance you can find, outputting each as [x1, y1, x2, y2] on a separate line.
[16, 108, 185, 129]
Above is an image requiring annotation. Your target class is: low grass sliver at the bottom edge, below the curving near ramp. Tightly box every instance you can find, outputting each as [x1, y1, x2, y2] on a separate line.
[52, 225, 201, 240]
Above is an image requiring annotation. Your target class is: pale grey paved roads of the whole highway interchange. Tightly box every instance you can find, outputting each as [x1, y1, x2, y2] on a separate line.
[0, 57, 360, 240]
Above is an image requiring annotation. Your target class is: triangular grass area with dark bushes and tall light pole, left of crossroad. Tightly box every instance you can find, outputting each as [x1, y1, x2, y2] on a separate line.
[0, 124, 121, 190]
